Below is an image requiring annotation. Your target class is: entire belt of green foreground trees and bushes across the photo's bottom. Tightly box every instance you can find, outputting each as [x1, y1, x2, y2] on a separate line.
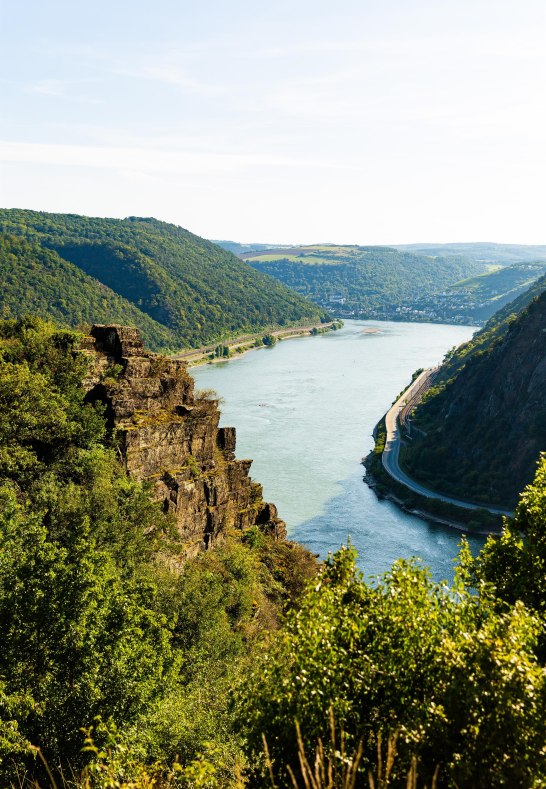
[0, 316, 546, 789]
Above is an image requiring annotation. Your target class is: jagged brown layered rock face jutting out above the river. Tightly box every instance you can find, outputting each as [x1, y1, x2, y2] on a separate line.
[83, 326, 286, 556]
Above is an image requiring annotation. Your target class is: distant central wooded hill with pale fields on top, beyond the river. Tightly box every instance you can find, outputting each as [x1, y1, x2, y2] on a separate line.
[238, 245, 484, 319]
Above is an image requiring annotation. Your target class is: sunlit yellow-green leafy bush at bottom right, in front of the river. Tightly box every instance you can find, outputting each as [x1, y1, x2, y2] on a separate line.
[243, 548, 546, 787]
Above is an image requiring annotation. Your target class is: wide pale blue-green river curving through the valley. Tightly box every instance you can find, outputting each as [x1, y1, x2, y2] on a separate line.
[191, 320, 483, 580]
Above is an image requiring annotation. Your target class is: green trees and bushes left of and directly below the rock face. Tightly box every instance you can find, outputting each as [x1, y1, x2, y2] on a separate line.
[0, 319, 314, 785]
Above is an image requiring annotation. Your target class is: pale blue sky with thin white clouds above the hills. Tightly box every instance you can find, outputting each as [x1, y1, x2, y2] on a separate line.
[0, 0, 546, 244]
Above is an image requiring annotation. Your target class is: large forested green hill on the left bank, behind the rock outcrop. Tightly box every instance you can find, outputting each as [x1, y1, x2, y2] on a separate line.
[0, 209, 325, 350]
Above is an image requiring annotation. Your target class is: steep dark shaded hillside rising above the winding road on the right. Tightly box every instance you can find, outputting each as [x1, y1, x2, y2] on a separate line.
[402, 277, 546, 507]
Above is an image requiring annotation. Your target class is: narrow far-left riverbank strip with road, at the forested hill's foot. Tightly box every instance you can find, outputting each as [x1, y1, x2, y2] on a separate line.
[173, 320, 343, 367]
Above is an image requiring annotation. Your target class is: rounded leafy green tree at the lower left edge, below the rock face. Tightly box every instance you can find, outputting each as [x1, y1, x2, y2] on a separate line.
[0, 487, 172, 765]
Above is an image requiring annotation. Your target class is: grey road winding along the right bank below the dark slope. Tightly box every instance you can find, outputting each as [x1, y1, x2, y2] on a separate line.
[381, 367, 513, 515]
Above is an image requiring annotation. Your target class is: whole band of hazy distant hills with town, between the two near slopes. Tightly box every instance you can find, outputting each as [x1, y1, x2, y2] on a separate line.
[218, 241, 546, 325]
